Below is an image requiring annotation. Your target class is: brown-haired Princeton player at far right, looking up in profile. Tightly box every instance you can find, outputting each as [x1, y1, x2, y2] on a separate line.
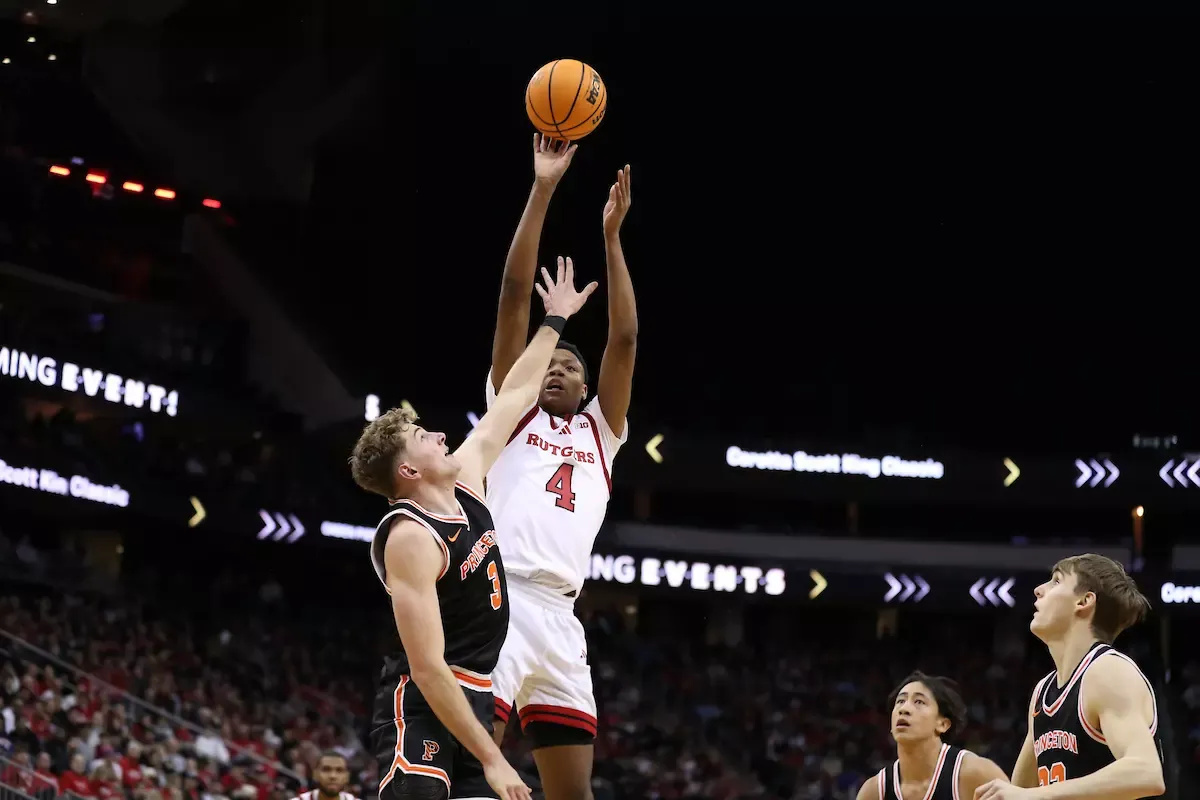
[976, 554, 1175, 800]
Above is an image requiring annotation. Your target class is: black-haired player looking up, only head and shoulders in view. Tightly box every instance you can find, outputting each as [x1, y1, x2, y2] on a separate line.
[858, 672, 1004, 800]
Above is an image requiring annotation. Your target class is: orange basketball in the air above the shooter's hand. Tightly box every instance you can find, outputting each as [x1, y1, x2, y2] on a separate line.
[526, 59, 608, 142]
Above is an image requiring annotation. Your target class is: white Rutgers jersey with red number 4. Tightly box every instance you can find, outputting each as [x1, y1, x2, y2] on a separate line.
[486, 373, 629, 594]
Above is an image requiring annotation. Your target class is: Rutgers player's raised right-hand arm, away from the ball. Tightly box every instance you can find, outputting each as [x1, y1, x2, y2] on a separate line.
[596, 164, 637, 439]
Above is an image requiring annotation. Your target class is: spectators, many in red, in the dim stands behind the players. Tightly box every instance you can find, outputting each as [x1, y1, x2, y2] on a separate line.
[0, 537, 1200, 800]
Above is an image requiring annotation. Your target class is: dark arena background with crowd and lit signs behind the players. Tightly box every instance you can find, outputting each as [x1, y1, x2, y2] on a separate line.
[0, 0, 1200, 800]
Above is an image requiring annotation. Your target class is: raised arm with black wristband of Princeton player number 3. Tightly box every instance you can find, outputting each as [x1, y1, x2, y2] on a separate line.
[455, 258, 596, 494]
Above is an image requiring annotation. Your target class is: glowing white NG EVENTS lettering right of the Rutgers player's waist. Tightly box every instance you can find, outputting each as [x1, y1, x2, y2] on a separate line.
[589, 553, 787, 596]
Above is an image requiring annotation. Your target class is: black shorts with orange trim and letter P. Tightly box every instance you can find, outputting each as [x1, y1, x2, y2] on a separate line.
[371, 675, 498, 800]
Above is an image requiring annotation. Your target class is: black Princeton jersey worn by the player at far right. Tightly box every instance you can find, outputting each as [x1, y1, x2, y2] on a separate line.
[1033, 643, 1175, 798]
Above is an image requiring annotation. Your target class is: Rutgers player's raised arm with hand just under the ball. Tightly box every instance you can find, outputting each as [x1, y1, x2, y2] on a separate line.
[492, 133, 575, 389]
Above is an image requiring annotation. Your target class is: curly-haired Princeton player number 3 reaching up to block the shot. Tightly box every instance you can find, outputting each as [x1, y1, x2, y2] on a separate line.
[350, 259, 596, 800]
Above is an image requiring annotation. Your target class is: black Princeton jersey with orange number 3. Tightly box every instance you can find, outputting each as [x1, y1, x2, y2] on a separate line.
[371, 483, 509, 680]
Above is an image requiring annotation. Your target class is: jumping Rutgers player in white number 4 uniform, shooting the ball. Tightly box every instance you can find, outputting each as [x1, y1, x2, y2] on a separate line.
[486, 136, 637, 800]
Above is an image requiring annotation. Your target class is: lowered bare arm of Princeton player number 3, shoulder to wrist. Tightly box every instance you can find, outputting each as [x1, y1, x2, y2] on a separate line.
[384, 519, 503, 765]
